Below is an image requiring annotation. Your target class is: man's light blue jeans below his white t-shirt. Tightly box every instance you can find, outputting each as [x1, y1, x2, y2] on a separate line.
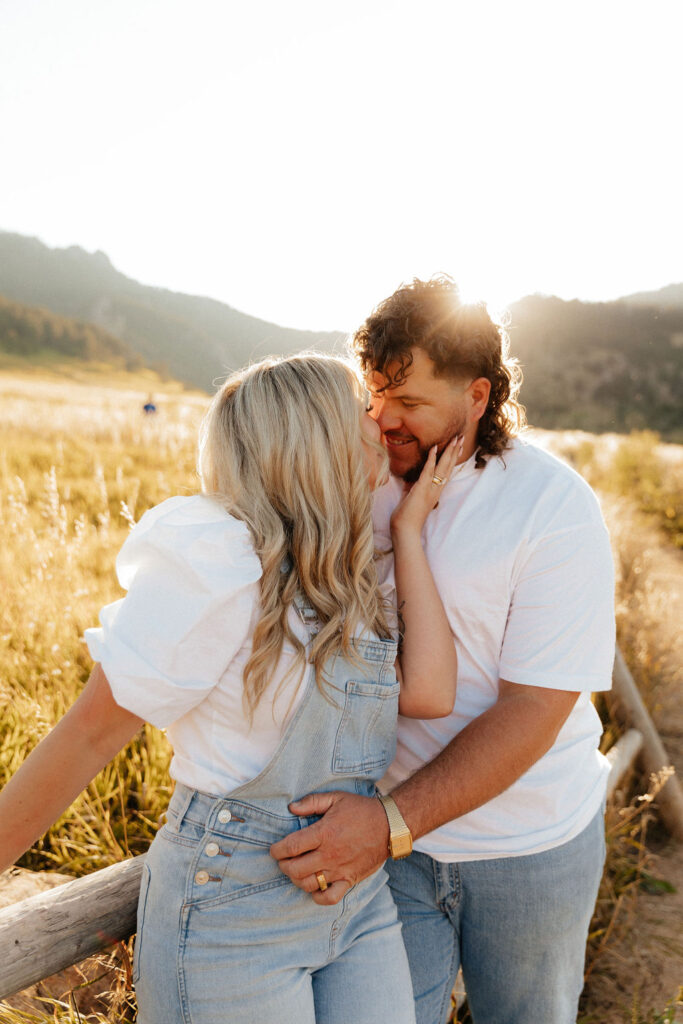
[386, 811, 605, 1024]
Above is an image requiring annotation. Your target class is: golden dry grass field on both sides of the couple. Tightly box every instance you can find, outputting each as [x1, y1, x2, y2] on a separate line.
[0, 369, 683, 1024]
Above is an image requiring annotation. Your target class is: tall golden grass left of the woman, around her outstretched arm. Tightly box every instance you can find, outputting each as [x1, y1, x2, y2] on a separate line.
[0, 384, 206, 874]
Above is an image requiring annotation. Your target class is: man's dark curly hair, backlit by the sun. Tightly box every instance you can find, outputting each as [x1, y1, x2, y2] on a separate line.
[351, 274, 526, 469]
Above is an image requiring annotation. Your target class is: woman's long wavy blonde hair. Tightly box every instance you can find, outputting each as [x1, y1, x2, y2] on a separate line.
[199, 352, 390, 718]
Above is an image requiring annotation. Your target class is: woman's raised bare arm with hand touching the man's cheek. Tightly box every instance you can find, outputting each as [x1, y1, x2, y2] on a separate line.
[391, 437, 462, 718]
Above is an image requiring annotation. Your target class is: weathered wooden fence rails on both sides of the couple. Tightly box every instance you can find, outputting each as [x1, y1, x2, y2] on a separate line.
[0, 650, 683, 999]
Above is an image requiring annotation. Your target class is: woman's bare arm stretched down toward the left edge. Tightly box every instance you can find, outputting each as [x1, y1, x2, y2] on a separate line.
[0, 665, 144, 871]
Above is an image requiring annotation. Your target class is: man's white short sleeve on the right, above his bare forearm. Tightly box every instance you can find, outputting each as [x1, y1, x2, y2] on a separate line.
[500, 515, 614, 691]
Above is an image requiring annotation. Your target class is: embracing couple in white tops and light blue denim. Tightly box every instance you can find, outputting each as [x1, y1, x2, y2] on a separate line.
[0, 278, 614, 1024]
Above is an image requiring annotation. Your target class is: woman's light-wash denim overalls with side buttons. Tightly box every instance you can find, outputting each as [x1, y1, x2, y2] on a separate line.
[134, 610, 415, 1024]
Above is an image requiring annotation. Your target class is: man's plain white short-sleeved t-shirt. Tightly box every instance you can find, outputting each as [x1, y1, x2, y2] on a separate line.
[374, 440, 614, 861]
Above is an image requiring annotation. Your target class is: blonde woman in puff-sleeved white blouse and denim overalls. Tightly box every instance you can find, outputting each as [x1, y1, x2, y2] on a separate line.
[0, 355, 457, 1024]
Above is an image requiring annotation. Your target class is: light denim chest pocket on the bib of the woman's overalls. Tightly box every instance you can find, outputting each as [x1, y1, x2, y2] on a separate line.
[332, 679, 400, 777]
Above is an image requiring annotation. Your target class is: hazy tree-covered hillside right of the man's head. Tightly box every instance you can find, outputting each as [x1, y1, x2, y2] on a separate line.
[509, 295, 683, 441]
